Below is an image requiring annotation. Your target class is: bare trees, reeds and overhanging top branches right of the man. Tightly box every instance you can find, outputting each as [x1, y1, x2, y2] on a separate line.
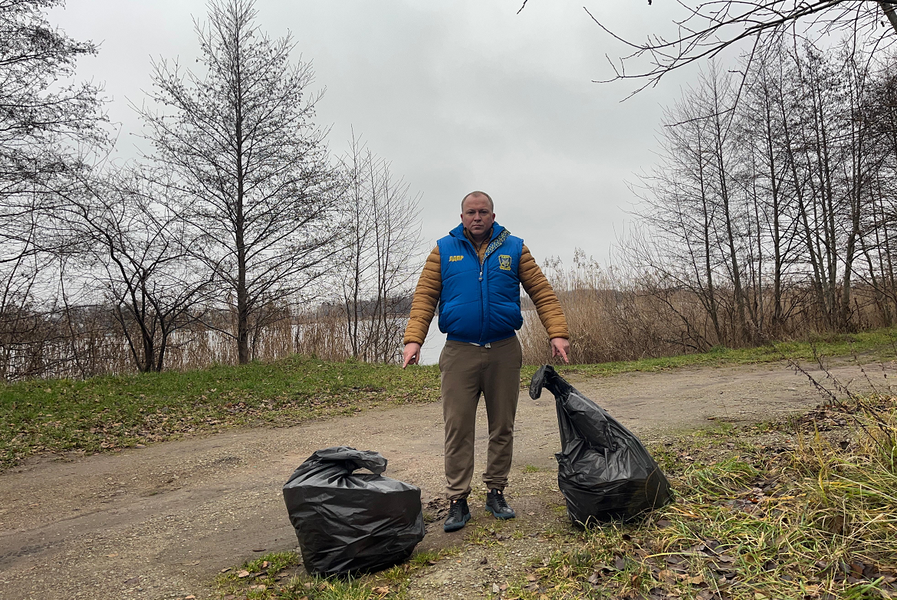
[521, 0, 897, 362]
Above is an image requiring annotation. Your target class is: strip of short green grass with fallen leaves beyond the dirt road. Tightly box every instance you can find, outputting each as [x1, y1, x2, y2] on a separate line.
[0, 329, 897, 470]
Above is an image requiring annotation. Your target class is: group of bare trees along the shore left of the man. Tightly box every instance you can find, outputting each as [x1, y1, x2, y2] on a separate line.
[0, 0, 418, 379]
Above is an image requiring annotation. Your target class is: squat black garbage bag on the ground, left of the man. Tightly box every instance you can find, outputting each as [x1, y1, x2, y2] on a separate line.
[283, 446, 425, 575]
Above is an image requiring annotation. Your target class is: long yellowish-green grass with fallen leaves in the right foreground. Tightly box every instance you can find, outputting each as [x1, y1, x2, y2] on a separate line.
[502, 398, 897, 600]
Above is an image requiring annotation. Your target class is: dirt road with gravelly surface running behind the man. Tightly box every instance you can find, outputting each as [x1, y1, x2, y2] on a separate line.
[0, 364, 897, 600]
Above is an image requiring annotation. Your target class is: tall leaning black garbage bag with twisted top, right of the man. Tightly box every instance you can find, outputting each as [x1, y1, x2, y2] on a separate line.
[529, 365, 672, 527]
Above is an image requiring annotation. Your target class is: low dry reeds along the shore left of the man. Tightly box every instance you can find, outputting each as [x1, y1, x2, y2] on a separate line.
[0, 306, 390, 381]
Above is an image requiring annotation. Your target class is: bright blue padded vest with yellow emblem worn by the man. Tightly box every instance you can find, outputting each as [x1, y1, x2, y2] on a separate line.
[436, 223, 523, 344]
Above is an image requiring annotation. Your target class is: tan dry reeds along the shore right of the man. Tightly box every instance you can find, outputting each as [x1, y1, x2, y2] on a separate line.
[520, 250, 895, 364]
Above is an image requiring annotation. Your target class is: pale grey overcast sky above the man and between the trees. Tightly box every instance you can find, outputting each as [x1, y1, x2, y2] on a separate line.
[50, 0, 696, 264]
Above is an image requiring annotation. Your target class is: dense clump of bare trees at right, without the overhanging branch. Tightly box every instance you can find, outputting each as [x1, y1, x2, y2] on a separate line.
[562, 35, 897, 360]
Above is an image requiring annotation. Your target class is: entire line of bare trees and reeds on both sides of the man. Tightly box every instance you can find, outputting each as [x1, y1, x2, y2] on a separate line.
[0, 0, 897, 379]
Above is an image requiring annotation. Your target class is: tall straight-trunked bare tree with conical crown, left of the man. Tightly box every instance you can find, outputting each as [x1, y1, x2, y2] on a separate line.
[139, 0, 338, 363]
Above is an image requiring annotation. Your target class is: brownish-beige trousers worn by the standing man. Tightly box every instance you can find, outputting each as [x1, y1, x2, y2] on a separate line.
[439, 336, 523, 500]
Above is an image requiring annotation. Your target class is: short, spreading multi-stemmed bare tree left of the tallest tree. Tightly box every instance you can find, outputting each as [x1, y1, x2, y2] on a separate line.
[60, 169, 212, 372]
